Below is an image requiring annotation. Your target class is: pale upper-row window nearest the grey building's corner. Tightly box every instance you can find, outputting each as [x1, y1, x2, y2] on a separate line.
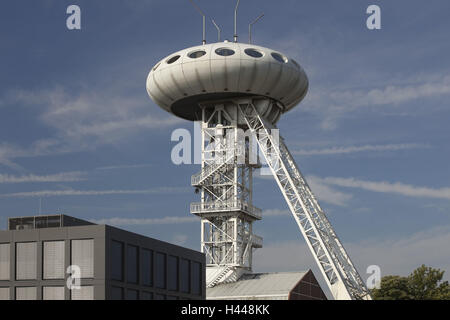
[71, 239, 94, 278]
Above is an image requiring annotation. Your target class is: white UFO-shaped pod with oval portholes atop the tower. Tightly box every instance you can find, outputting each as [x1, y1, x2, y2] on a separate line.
[147, 42, 308, 122]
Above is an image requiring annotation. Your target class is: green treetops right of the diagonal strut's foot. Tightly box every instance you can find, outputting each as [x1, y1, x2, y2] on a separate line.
[372, 265, 450, 300]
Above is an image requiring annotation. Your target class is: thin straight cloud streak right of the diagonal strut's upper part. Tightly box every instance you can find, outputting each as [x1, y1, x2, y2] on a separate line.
[292, 143, 428, 156]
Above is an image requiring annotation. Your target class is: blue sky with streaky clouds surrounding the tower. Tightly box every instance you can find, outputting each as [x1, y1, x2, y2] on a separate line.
[0, 0, 450, 292]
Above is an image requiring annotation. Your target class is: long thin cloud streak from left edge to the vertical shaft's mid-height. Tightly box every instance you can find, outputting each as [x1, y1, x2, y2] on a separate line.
[0, 187, 189, 198]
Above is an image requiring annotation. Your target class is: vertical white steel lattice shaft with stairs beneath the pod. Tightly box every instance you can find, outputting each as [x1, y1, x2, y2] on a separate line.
[191, 104, 262, 287]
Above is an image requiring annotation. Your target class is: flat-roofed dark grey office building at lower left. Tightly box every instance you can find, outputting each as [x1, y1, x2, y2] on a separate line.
[0, 215, 206, 300]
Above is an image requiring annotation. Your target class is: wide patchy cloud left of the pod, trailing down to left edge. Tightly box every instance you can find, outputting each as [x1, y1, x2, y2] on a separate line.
[0, 88, 183, 170]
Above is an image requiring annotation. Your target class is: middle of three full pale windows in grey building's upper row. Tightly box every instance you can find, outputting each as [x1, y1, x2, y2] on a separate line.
[43, 241, 65, 279]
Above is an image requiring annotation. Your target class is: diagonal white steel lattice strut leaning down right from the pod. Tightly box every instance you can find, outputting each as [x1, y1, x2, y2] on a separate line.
[236, 101, 371, 300]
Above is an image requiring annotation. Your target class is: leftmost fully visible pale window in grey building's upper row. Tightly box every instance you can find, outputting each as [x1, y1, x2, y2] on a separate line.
[16, 242, 37, 280]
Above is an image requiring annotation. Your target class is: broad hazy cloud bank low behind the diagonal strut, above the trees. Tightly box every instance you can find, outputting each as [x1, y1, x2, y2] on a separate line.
[254, 226, 450, 294]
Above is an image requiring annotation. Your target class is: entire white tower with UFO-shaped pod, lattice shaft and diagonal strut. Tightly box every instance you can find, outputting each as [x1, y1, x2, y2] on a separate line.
[147, 41, 371, 299]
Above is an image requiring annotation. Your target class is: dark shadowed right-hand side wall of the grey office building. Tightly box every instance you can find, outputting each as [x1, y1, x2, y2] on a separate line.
[105, 226, 206, 300]
